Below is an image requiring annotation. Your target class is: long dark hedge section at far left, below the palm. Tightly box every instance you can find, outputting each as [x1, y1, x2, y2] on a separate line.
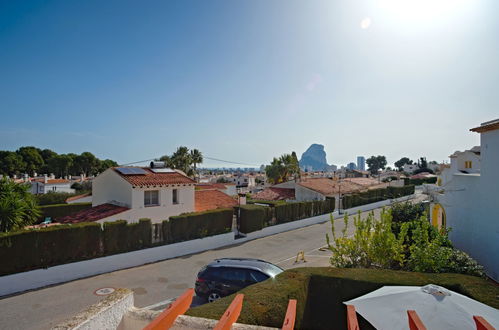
[0, 222, 102, 275]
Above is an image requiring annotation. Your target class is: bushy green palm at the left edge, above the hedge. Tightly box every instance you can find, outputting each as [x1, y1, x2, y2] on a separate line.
[0, 177, 41, 232]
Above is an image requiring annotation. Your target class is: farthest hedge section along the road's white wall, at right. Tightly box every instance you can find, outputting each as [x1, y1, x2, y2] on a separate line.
[342, 185, 415, 209]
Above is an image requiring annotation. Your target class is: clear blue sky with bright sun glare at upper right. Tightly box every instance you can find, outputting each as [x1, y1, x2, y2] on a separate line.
[0, 0, 499, 167]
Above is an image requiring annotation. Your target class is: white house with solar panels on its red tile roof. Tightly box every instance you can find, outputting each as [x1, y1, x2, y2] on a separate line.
[92, 167, 195, 223]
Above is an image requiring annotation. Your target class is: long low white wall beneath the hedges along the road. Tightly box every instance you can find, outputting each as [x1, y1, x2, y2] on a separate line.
[0, 195, 416, 296]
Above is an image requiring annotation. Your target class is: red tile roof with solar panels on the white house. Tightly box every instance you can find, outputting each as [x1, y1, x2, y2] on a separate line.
[113, 167, 196, 187]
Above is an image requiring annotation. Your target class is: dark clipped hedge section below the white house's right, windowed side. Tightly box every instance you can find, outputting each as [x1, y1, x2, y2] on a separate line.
[162, 209, 234, 244]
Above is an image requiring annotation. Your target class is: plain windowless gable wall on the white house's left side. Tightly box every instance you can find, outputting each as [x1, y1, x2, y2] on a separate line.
[92, 168, 132, 207]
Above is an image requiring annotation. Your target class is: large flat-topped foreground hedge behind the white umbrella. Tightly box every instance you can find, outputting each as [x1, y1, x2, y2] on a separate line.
[186, 267, 499, 329]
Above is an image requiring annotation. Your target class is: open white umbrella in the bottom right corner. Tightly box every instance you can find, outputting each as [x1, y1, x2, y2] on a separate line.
[344, 284, 499, 330]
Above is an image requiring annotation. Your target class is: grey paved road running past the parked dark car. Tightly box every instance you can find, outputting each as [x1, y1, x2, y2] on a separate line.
[0, 197, 422, 329]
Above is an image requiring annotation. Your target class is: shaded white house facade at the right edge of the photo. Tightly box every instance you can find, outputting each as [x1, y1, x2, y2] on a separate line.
[431, 119, 499, 281]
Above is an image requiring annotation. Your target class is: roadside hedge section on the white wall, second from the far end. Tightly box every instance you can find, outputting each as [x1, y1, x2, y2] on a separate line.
[274, 198, 335, 224]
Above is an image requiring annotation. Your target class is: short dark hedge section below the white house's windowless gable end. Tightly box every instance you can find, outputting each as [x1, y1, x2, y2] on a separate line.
[103, 219, 152, 255]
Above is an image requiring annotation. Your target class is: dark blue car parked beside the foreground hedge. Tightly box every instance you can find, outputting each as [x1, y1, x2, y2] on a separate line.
[195, 258, 283, 302]
